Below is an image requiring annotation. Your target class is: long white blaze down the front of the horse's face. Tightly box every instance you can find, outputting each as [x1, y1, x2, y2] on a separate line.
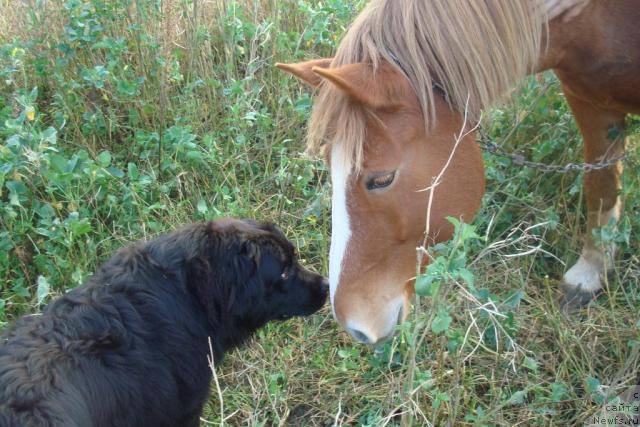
[329, 144, 351, 315]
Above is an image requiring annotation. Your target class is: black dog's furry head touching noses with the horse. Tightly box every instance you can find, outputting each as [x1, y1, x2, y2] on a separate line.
[187, 219, 328, 339]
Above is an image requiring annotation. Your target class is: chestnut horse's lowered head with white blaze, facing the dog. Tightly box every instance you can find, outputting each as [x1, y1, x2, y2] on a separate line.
[278, 60, 484, 344]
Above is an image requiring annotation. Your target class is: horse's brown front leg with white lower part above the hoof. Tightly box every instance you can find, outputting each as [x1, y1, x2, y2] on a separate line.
[563, 85, 625, 307]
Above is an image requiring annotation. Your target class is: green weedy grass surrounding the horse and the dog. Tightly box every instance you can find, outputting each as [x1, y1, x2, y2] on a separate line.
[0, 0, 640, 426]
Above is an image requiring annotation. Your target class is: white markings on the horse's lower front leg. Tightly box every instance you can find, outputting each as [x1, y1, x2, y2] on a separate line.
[564, 198, 622, 292]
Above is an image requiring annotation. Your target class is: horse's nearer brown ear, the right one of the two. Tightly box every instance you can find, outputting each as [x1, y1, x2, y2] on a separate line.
[312, 61, 408, 109]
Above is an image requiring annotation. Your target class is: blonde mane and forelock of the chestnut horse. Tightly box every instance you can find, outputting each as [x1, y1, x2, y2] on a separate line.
[308, 0, 546, 171]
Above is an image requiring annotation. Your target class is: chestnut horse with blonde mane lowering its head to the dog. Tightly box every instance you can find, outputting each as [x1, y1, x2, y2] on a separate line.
[278, 0, 640, 344]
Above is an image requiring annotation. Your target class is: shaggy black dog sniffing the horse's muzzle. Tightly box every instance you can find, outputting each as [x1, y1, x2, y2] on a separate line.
[0, 220, 327, 427]
